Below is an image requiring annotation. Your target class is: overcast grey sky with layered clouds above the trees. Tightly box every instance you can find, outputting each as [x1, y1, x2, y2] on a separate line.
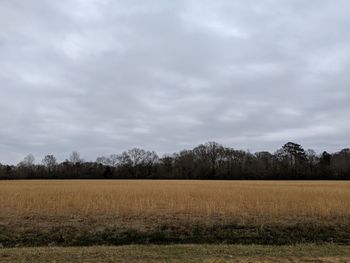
[0, 0, 350, 164]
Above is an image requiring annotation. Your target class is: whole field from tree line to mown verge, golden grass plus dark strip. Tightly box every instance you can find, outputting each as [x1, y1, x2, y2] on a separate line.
[0, 180, 350, 251]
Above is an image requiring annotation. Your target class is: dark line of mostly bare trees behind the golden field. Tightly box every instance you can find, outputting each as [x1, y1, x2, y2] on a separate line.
[0, 142, 350, 180]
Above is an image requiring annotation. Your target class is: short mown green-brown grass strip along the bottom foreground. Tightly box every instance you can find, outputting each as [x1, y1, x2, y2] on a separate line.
[0, 244, 350, 263]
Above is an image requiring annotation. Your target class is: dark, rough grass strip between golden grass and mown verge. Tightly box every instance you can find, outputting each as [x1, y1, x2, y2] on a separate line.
[0, 218, 350, 247]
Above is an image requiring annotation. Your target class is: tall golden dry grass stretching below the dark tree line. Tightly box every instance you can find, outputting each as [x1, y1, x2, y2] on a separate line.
[0, 180, 350, 220]
